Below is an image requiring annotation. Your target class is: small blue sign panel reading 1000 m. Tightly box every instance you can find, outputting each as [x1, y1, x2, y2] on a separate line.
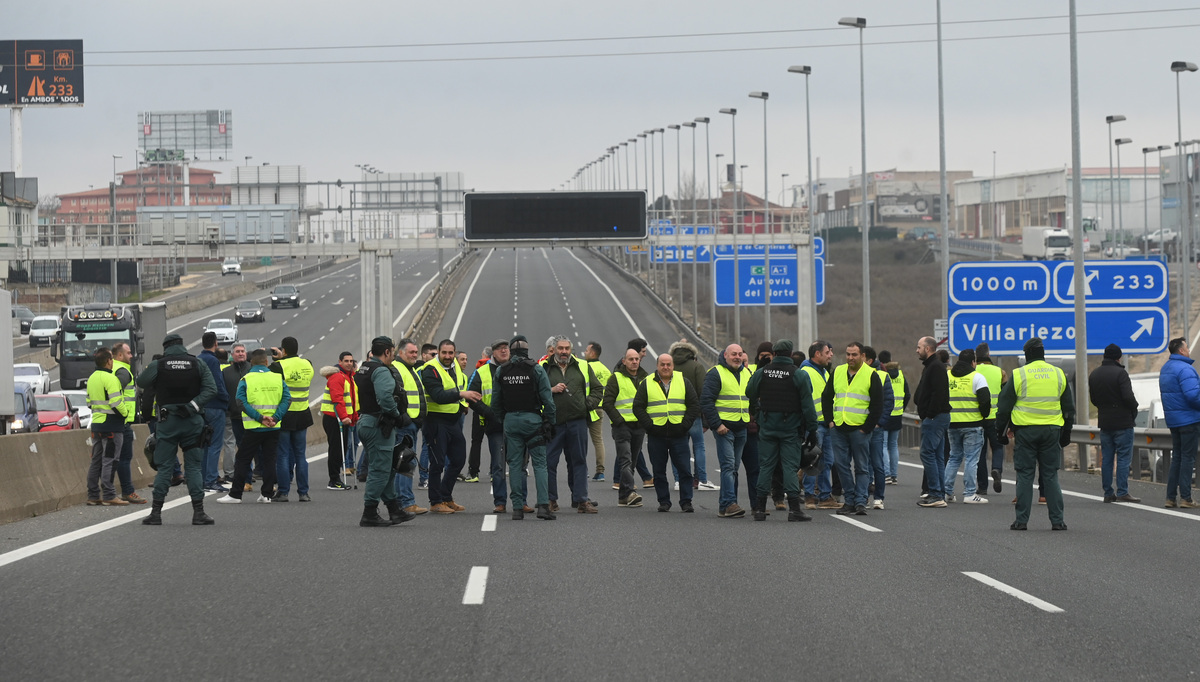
[948, 261, 1050, 309]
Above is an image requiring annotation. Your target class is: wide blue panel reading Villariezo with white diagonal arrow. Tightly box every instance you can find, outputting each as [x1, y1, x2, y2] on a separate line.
[949, 306, 1168, 355]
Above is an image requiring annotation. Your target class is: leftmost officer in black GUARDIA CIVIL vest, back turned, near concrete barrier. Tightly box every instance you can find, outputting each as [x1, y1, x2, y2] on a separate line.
[138, 334, 217, 526]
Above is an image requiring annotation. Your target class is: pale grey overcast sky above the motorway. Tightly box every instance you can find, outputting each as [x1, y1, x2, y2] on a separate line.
[0, 0, 1200, 201]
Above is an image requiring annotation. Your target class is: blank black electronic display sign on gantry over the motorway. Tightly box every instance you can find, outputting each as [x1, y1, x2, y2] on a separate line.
[466, 191, 646, 241]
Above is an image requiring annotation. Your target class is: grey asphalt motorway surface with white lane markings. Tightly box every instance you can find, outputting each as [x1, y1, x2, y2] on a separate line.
[0, 250, 1200, 680]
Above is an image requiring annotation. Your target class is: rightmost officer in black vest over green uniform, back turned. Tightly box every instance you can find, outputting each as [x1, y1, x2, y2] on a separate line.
[746, 339, 817, 521]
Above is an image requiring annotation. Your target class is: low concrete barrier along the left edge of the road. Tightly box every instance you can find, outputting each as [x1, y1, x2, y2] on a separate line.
[0, 424, 155, 524]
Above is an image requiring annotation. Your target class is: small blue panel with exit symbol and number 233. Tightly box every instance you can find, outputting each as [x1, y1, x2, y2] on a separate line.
[1054, 261, 1168, 304]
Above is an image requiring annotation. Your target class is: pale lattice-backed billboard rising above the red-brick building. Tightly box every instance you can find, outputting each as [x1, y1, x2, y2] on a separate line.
[138, 109, 233, 163]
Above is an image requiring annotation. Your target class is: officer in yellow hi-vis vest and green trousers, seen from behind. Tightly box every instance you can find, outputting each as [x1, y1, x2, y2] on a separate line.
[996, 336, 1075, 531]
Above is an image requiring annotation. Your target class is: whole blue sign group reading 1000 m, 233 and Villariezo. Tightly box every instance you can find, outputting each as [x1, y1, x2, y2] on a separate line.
[948, 259, 1170, 355]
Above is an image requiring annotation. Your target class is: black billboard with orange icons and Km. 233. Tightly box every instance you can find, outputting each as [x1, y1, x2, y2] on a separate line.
[0, 40, 83, 107]
